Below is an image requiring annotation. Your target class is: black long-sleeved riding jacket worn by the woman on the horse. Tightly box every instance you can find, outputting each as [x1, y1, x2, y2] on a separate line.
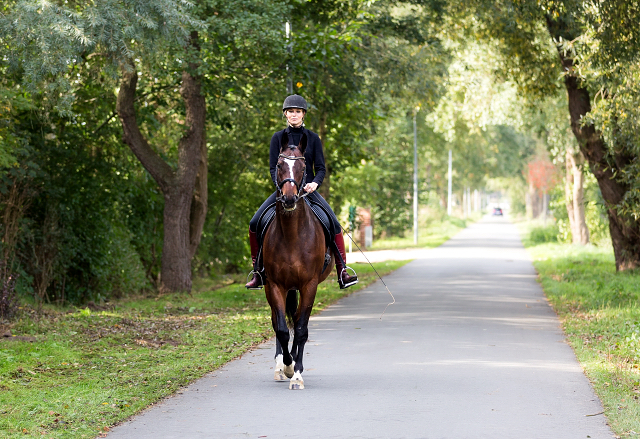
[269, 127, 327, 187]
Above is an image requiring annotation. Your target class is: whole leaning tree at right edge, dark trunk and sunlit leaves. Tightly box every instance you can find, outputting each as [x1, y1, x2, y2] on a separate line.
[454, 0, 640, 270]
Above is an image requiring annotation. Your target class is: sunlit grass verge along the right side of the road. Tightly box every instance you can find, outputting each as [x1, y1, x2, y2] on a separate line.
[529, 243, 640, 437]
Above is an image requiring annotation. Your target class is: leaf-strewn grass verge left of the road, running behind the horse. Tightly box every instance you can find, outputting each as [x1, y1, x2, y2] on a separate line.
[0, 261, 407, 438]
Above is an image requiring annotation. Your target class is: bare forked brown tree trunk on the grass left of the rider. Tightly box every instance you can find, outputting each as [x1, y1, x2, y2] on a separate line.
[116, 32, 207, 292]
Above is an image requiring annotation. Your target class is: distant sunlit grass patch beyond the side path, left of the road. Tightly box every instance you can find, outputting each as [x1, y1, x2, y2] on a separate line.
[367, 215, 480, 250]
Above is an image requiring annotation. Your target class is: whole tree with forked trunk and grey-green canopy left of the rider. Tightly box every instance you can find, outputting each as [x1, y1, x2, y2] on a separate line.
[2, 0, 286, 291]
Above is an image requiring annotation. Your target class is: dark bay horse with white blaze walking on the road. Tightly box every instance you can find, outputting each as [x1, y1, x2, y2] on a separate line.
[263, 133, 334, 389]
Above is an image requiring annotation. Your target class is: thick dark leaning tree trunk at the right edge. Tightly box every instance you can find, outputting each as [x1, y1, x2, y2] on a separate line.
[547, 17, 640, 271]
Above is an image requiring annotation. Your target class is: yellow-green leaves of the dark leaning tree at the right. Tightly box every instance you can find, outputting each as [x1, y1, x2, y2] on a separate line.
[454, 0, 640, 254]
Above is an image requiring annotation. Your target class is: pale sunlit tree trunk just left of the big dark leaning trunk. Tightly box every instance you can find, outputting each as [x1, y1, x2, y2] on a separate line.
[565, 150, 589, 245]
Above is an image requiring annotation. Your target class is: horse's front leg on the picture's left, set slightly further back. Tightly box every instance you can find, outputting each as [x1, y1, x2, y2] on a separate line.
[265, 282, 294, 381]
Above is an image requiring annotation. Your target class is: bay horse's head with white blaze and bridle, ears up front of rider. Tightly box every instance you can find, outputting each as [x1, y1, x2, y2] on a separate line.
[276, 133, 306, 211]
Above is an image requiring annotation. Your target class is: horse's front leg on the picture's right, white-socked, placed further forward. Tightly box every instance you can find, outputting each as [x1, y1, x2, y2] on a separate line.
[289, 280, 318, 390]
